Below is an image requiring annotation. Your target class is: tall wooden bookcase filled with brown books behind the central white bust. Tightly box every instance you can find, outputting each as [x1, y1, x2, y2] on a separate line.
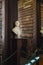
[18, 0, 37, 62]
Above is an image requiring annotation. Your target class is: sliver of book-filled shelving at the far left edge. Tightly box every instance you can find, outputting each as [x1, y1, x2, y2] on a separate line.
[0, 0, 2, 63]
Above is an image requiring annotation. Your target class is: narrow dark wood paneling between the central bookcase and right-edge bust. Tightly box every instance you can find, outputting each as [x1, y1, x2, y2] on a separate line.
[36, 0, 41, 48]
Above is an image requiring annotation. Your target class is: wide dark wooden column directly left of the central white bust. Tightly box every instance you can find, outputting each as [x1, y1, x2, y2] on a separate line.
[3, 0, 18, 65]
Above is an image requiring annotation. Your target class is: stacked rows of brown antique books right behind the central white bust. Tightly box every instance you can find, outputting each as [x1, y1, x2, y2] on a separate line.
[18, 0, 36, 38]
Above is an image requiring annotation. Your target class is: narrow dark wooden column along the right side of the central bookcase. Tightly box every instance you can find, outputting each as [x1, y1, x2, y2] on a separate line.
[36, 0, 41, 65]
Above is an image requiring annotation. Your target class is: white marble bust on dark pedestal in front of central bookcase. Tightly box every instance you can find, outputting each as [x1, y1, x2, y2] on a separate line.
[12, 21, 22, 38]
